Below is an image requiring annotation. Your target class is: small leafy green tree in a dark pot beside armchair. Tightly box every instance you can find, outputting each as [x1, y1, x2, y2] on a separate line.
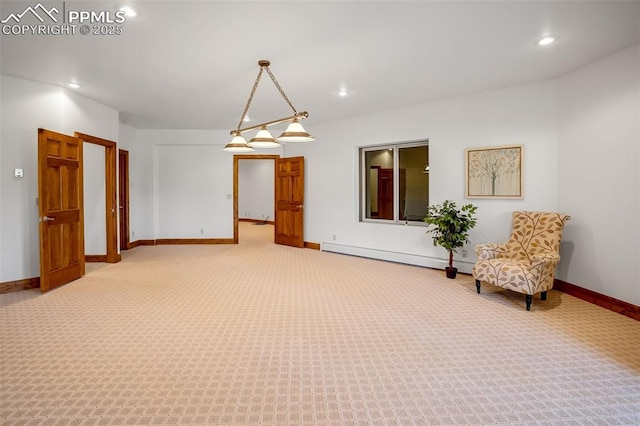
[423, 200, 478, 278]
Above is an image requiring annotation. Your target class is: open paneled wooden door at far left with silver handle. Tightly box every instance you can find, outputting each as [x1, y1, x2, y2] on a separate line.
[38, 129, 84, 292]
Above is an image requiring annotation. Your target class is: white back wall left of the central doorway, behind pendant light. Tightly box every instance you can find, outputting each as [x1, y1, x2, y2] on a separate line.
[132, 130, 249, 239]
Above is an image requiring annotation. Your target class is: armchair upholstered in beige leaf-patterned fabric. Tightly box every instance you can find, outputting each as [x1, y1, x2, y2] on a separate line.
[472, 212, 571, 311]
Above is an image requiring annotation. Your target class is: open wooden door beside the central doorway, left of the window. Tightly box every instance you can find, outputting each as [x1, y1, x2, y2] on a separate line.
[275, 157, 304, 247]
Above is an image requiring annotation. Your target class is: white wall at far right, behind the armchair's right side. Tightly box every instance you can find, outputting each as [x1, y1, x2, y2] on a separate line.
[558, 45, 640, 306]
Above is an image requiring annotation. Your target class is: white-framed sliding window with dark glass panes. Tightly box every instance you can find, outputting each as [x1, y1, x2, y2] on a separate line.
[358, 139, 430, 226]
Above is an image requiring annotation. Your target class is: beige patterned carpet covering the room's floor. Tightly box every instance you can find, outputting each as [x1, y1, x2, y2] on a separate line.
[0, 223, 640, 425]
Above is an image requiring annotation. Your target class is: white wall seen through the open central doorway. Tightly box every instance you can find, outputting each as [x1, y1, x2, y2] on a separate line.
[238, 159, 275, 221]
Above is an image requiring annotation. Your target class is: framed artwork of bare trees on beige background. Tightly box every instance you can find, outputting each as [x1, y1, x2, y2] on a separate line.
[465, 145, 523, 198]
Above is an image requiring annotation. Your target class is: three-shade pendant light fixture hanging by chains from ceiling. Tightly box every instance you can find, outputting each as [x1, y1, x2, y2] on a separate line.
[223, 59, 315, 153]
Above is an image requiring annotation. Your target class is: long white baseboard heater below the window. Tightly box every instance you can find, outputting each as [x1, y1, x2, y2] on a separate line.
[320, 242, 474, 274]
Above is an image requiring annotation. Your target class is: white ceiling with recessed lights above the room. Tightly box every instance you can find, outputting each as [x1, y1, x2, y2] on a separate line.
[0, 0, 640, 130]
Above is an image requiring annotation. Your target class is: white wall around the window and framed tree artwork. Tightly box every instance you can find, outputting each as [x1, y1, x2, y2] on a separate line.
[286, 81, 557, 270]
